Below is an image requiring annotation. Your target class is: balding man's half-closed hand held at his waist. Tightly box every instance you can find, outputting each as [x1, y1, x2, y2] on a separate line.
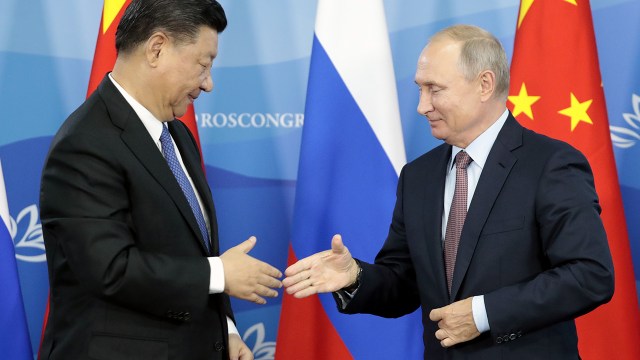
[429, 298, 480, 347]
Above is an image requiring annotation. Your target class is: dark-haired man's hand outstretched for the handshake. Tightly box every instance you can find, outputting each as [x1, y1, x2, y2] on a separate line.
[220, 236, 282, 304]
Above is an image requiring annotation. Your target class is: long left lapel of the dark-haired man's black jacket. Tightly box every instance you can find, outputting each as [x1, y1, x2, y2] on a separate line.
[98, 75, 211, 253]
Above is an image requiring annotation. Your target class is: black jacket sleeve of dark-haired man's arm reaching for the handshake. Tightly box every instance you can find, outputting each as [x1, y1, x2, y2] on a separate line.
[41, 129, 215, 316]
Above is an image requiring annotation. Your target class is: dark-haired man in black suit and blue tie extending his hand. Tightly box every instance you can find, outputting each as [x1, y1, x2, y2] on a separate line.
[40, 0, 281, 360]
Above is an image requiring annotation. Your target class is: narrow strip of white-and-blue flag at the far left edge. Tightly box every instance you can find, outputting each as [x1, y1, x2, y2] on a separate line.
[0, 161, 33, 360]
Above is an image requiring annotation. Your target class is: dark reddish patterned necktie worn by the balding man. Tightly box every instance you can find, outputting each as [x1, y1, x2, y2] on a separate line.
[444, 151, 473, 293]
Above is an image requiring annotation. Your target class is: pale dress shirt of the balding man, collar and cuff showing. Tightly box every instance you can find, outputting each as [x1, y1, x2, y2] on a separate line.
[442, 110, 509, 333]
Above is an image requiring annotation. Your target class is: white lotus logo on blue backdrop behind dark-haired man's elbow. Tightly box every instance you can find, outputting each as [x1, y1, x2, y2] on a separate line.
[9, 204, 47, 263]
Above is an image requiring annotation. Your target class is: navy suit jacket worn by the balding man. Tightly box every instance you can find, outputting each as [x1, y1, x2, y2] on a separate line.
[345, 114, 614, 360]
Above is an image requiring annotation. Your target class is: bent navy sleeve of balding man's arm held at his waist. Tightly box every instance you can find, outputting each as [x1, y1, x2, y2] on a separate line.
[485, 146, 614, 334]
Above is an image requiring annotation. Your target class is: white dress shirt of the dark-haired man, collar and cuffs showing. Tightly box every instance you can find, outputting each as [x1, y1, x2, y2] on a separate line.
[109, 74, 239, 334]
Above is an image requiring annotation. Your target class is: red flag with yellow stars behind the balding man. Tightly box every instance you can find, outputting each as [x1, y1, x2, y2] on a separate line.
[508, 0, 640, 360]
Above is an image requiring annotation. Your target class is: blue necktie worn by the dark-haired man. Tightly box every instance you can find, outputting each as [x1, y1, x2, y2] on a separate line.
[160, 124, 211, 254]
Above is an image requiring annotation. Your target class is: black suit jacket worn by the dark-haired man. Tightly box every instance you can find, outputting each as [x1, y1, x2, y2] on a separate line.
[40, 77, 232, 360]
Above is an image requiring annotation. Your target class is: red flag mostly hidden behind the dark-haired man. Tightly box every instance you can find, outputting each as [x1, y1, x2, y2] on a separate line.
[38, 0, 204, 358]
